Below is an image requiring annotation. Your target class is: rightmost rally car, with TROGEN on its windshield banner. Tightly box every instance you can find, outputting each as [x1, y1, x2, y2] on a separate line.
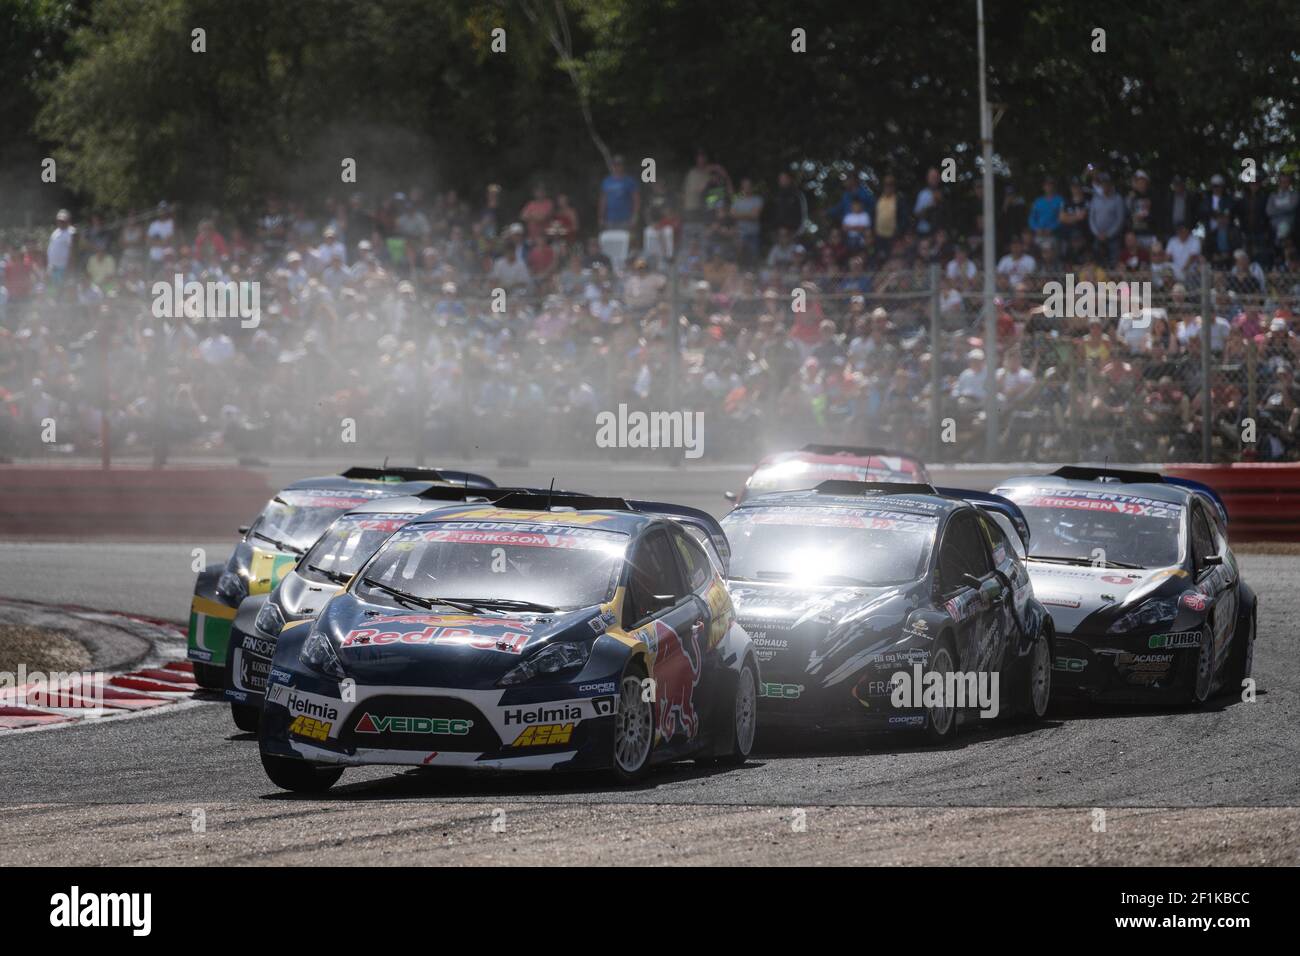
[996, 466, 1256, 706]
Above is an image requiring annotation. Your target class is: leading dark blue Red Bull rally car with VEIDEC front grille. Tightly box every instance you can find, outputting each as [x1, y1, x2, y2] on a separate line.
[259, 494, 759, 791]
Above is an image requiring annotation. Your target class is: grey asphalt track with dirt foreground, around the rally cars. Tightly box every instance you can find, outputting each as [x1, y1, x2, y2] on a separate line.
[0, 470, 1300, 865]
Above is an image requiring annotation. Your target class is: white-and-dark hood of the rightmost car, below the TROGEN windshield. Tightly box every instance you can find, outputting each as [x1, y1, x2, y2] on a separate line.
[1024, 558, 1187, 635]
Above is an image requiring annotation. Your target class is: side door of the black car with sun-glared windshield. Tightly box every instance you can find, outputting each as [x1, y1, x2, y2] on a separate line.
[937, 510, 1010, 671]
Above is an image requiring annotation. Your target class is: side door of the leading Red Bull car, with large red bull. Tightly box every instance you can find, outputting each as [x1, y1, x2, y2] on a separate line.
[623, 525, 707, 752]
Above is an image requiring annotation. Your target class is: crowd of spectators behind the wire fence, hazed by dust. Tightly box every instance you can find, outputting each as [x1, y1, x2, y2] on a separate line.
[0, 151, 1300, 460]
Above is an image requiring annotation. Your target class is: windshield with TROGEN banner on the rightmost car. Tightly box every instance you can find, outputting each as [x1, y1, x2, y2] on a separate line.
[1000, 488, 1183, 567]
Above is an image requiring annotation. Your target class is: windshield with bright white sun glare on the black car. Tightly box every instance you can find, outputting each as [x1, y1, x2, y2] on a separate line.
[723, 507, 939, 587]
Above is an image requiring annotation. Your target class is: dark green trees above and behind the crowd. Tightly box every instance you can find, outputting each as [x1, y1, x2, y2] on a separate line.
[12, 0, 1300, 208]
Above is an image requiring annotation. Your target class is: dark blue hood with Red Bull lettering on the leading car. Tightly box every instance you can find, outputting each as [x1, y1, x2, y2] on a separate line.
[313, 593, 607, 688]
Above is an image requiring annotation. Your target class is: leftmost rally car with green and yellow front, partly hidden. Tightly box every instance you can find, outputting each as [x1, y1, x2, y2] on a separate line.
[186, 466, 497, 691]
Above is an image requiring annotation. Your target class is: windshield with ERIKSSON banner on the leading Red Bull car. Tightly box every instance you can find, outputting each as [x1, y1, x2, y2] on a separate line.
[358, 522, 628, 610]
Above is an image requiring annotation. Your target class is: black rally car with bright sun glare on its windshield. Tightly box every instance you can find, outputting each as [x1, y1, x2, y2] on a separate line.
[723, 480, 1054, 740]
